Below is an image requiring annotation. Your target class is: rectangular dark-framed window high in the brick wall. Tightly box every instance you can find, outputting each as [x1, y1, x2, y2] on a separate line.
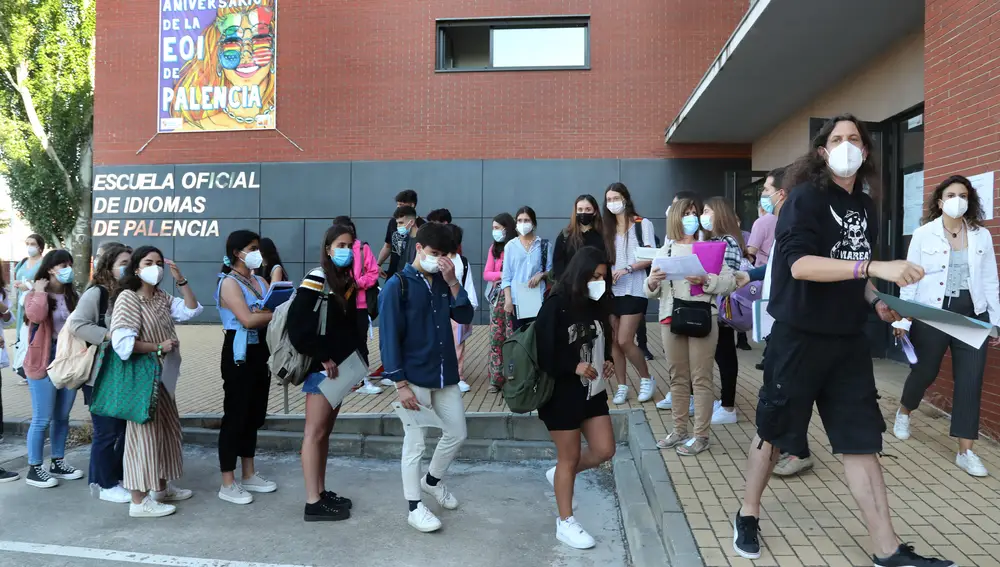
[437, 16, 590, 71]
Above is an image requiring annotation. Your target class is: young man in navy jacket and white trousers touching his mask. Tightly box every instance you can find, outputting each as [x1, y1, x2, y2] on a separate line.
[379, 223, 475, 533]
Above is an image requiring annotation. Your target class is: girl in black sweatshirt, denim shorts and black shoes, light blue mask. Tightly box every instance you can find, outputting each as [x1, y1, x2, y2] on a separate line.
[284, 224, 360, 522]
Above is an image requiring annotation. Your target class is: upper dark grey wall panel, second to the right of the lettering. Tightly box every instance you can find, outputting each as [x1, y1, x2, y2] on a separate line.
[351, 160, 483, 218]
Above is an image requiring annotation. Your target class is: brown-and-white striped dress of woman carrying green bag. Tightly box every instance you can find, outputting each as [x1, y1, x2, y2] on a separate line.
[111, 290, 183, 492]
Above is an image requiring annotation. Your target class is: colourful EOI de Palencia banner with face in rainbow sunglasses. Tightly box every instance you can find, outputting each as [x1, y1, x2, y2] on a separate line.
[157, 0, 278, 133]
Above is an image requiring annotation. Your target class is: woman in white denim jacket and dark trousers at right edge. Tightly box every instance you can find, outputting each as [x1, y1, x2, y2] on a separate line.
[893, 175, 1000, 476]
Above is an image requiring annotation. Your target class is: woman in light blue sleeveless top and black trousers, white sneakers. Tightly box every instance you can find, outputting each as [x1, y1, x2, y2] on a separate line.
[215, 230, 278, 504]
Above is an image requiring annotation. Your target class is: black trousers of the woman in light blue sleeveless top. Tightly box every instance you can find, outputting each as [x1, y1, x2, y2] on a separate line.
[219, 329, 271, 472]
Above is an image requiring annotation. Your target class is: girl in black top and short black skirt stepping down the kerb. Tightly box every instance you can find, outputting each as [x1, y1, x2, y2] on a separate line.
[535, 246, 615, 549]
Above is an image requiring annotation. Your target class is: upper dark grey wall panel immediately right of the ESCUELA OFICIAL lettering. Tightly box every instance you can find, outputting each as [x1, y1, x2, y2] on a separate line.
[260, 162, 351, 219]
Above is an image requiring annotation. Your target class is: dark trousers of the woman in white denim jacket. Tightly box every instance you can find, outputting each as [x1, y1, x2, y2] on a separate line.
[900, 290, 989, 439]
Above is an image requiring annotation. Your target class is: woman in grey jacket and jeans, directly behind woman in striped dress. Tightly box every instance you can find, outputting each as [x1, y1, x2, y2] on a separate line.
[66, 243, 132, 504]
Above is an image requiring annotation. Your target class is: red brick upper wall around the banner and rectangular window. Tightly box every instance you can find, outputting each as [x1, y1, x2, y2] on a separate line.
[95, 0, 750, 165]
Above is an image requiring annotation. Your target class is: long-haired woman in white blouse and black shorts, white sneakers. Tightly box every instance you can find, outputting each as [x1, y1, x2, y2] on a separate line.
[604, 183, 656, 404]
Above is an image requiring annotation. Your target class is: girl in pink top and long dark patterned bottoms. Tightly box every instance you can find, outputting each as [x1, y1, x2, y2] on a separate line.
[483, 213, 517, 393]
